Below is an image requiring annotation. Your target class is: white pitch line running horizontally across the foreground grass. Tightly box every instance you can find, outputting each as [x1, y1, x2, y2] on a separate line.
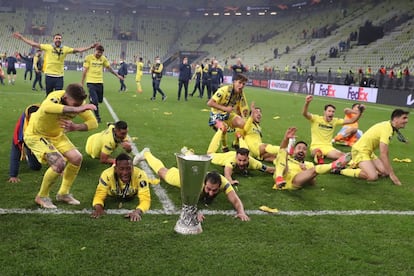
[0, 208, 414, 217]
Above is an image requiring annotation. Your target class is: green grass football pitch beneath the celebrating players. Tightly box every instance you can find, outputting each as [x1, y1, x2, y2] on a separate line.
[0, 70, 414, 275]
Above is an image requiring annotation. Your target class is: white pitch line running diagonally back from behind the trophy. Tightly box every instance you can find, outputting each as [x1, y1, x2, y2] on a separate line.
[103, 97, 176, 213]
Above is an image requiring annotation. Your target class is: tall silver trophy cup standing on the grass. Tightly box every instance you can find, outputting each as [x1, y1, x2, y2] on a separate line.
[174, 153, 211, 235]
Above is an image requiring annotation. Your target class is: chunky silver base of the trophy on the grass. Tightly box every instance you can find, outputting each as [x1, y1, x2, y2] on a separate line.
[174, 205, 203, 235]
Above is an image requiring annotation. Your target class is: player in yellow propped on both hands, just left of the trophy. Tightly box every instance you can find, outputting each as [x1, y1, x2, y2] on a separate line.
[91, 153, 151, 221]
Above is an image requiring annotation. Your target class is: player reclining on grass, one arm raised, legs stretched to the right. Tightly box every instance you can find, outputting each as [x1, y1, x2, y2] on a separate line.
[273, 128, 350, 190]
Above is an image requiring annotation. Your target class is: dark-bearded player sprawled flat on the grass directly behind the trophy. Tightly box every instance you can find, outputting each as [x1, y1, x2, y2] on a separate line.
[134, 148, 250, 222]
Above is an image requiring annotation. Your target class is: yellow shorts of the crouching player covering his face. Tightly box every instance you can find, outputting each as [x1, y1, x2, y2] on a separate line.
[24, 135, 76, 164]
